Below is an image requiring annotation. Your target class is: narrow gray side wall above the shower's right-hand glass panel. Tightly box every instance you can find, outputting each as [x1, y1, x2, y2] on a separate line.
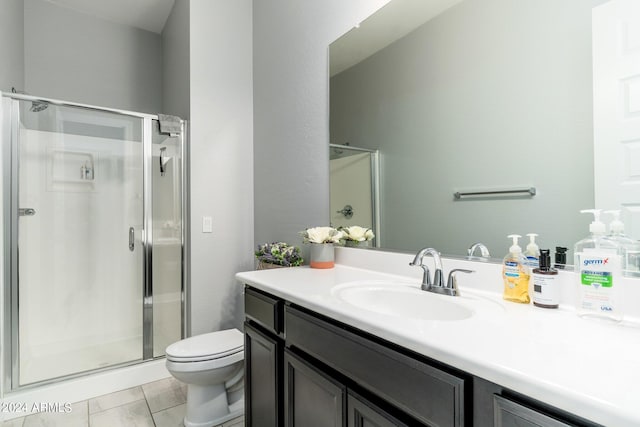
[162, 0, 189, 118]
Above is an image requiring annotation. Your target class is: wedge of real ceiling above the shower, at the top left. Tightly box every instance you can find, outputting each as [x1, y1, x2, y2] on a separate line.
[47, 0, 175, 34]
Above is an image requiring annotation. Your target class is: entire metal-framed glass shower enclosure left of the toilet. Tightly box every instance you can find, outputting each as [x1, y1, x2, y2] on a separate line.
[1, 94, 186, 390]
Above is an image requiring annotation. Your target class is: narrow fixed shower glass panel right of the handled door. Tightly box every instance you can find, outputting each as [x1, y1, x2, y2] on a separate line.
[151, 120, 185, 357]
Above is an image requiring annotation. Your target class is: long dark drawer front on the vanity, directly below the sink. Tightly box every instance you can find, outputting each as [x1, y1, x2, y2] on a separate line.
[285, 306, 464, 426]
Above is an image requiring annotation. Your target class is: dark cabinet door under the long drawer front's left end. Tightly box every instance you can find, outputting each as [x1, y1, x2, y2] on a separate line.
[284, 350, 346, 427]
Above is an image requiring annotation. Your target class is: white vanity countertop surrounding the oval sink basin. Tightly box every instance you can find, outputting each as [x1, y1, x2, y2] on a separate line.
[236, 251, 640, 426]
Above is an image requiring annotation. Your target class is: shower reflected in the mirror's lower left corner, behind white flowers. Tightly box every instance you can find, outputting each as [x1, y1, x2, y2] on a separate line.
[329, 142, 381, 247]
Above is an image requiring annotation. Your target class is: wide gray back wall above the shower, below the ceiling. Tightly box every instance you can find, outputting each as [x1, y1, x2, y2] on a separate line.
[24, 0, 162, 113]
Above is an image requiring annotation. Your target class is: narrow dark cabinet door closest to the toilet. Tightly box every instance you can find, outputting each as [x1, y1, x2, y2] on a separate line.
[244, 323, 283, 427]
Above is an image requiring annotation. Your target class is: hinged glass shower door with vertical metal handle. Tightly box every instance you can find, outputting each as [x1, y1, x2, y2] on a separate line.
[13, 100, 144, 386]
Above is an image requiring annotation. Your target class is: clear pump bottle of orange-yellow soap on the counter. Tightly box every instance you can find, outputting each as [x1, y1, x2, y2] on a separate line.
[502, 234, 530, 304]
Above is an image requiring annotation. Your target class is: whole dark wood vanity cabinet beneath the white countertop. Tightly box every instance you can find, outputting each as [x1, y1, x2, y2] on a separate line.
[245, 287, 596, 427]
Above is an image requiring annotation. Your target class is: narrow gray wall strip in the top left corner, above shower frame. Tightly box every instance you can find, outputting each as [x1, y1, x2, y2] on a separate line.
[0, 0, 24, 92]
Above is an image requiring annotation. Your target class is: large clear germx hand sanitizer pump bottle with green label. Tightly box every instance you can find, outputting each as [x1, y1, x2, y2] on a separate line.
[574, 209, 622, 322]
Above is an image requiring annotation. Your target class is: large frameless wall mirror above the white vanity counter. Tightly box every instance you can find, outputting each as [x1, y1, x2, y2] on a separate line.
[329, 0, 640, 262]
